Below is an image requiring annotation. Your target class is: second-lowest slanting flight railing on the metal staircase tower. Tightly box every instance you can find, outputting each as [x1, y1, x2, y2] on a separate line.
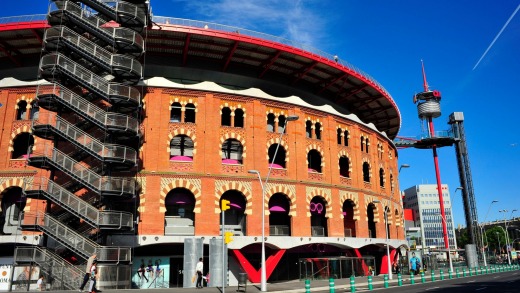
[20, 212, 131, 262]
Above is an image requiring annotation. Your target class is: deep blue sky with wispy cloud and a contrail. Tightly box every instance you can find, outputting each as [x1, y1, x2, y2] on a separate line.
[0, 0, 520, 225]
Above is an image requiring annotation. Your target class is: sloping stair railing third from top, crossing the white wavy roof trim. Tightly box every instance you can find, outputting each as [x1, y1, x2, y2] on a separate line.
[40, 53, 141, 105]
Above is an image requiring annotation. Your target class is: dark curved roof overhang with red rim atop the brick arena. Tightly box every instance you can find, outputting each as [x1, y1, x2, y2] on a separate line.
[0, 18, 401, 139]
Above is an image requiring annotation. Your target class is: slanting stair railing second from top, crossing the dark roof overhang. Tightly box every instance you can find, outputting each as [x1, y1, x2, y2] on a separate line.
[43, 26, 143, 78]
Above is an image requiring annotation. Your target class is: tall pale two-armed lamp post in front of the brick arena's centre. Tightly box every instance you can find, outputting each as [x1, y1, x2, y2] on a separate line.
[248, 115, 299, 292]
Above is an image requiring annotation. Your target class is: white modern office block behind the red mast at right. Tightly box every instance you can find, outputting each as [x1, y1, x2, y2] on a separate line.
[403, 184, 457, 251]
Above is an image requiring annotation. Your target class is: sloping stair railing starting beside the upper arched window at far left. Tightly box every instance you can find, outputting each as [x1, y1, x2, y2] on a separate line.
[28, 144, 137, 195]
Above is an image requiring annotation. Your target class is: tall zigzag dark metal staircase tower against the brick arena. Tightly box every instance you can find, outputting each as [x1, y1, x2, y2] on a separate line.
[21, 0, 150, 289]
